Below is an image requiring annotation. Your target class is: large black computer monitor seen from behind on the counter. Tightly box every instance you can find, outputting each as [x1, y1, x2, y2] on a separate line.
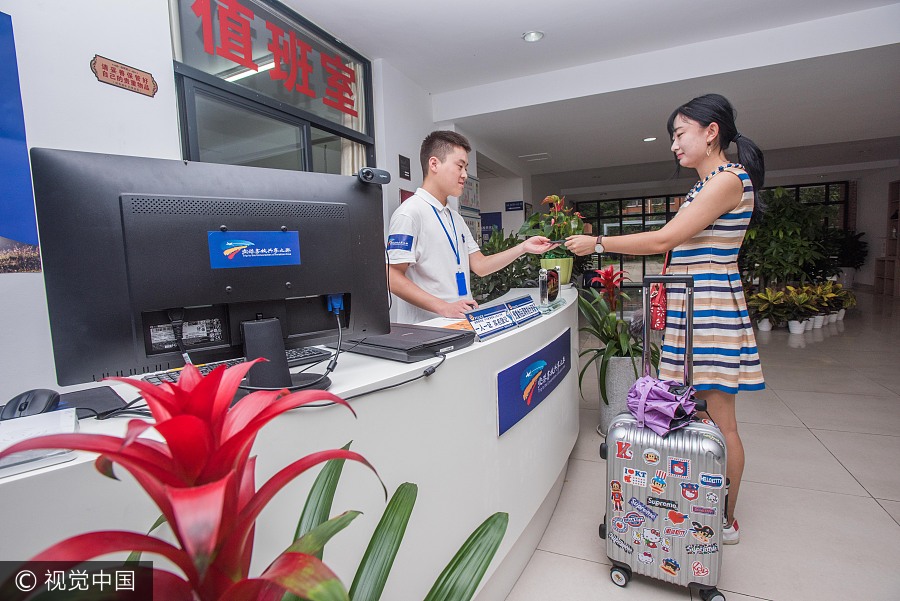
[31, 148, 390, 385]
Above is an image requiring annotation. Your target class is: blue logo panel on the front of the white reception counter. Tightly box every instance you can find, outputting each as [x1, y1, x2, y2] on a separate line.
[497, 330, 572, 436]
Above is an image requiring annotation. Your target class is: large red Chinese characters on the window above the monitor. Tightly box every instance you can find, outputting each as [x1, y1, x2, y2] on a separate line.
[191, 0, 359, 117]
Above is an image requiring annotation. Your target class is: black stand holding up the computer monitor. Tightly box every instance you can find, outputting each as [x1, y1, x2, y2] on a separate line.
[235, 317, 331, 402]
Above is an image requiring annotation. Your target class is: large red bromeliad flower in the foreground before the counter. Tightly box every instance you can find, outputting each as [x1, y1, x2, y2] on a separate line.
[0, 361, 374, 601]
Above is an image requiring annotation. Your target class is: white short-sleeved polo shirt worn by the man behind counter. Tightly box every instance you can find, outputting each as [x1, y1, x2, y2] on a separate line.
[387, 188, 480, 323]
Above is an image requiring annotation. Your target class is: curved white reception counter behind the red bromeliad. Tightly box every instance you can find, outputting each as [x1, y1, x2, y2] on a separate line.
[0, 289, 579, 601]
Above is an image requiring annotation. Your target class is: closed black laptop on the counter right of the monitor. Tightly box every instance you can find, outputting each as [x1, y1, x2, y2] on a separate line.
[341, 323, 475, 363]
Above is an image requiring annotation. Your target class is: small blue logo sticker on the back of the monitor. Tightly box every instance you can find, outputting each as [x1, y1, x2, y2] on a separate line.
[207, 231, 300, 269]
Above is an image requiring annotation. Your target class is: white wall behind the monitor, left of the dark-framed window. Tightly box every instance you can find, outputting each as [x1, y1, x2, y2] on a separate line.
[0, 0, 181, 404]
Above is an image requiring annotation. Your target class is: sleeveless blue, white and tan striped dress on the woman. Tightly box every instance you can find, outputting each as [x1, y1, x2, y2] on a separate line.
[660, 164, 766, 394]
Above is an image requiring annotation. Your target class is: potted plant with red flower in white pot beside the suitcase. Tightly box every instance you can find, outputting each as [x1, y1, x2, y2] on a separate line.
[578, 265, 659, 436]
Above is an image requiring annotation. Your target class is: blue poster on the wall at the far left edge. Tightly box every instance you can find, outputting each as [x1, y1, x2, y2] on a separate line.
[0, 12, 41, 273]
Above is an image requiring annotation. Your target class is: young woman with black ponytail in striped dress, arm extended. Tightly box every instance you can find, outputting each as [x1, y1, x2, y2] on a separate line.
[566, 94, 765, 544]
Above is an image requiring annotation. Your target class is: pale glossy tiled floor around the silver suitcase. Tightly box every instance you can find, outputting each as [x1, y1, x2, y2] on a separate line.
[507, 293, 900, 601]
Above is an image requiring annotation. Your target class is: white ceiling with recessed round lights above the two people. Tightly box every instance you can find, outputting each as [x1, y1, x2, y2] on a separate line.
[282, 0, 900, 189]
